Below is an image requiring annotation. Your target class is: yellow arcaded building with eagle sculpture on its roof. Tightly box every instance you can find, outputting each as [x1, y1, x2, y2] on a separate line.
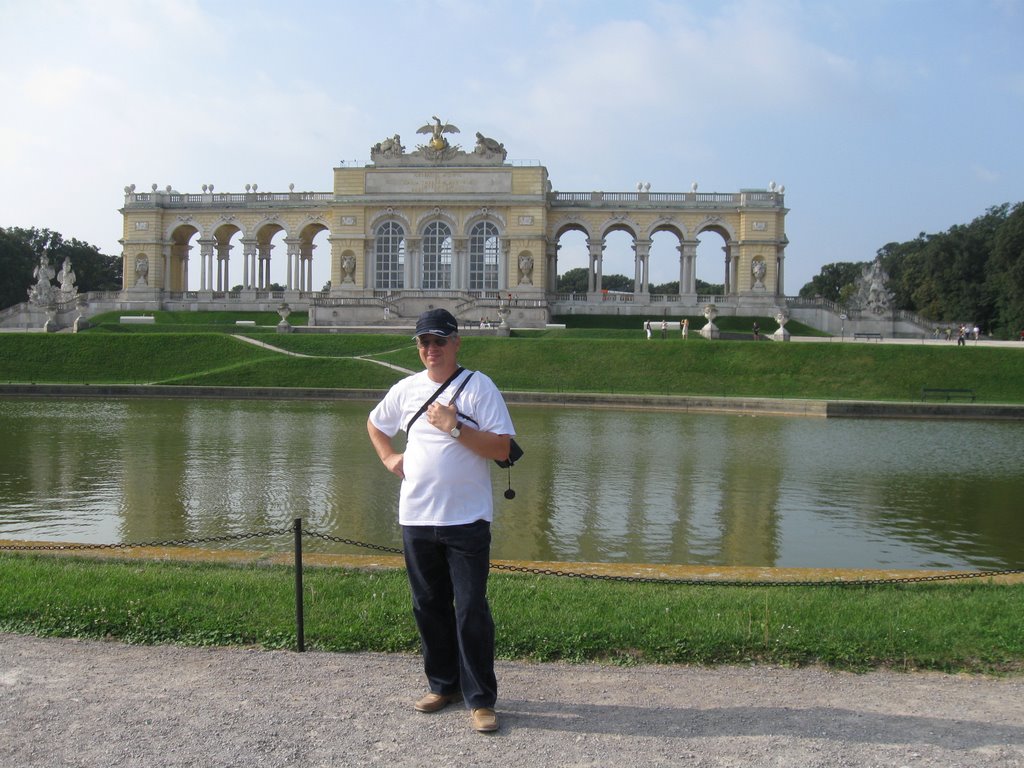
[116, 118, 787, 327]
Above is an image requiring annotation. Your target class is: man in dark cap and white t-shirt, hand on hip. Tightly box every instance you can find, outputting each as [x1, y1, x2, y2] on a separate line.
[367, 309, 515, 731]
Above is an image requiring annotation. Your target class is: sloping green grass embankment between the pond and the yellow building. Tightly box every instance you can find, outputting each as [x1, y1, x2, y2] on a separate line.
[0, 313, 1024, 403]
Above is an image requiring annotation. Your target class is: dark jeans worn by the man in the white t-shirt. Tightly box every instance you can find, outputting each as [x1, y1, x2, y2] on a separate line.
[401, 520, 498, 709]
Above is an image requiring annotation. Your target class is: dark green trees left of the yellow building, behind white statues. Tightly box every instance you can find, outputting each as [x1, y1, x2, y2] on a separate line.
[0, 226, 122, 309]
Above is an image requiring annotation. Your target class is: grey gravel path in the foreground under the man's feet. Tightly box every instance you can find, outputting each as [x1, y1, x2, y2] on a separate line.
[0, 634, 1024, 768]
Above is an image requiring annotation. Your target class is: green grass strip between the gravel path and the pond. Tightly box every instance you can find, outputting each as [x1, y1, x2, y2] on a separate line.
[0, 552, 1024, 674]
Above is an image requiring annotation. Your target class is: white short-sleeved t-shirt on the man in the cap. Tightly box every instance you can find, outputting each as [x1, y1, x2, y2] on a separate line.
[370, 371, 515, 525]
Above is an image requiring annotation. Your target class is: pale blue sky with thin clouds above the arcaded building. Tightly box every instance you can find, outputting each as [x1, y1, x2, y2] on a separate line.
[0, 0, 1024, 294]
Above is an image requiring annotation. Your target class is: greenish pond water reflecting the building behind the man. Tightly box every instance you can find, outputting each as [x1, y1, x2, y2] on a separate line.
[0, 399, 1024, 568]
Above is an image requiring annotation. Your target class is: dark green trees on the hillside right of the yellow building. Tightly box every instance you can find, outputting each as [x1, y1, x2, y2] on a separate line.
[800, 203, 1024, 339]
